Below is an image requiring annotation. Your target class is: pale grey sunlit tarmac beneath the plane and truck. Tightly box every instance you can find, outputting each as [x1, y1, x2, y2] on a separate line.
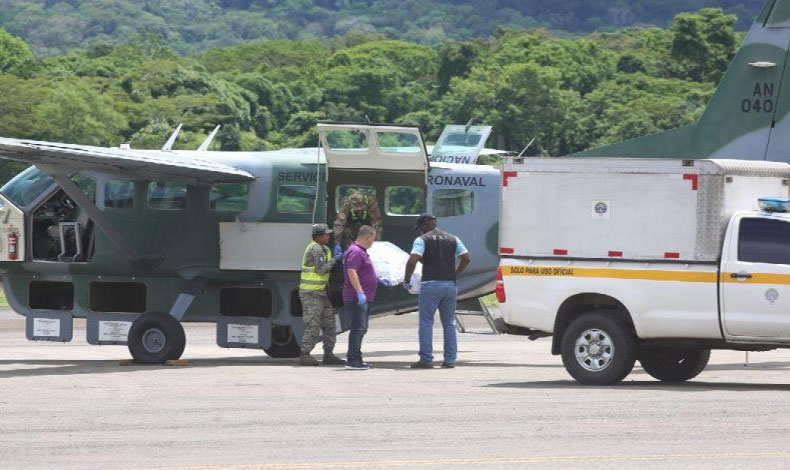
[0, 311, 790, 470]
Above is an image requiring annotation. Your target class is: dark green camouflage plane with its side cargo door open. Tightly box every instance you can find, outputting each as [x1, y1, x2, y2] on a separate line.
[0, 123, 500, 363]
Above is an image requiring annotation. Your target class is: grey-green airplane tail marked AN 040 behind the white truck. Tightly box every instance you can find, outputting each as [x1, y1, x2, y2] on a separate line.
[572, 0, 790, 162]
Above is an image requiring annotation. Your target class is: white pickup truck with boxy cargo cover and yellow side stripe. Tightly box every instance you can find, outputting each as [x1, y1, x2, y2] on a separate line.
[496, 158, 790, 385]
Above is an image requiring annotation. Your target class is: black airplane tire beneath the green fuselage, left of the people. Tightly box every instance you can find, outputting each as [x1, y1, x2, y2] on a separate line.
[128, 313, 186, 364]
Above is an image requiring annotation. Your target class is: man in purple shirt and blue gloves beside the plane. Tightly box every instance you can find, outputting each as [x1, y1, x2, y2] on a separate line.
[343, 225, 378, 370]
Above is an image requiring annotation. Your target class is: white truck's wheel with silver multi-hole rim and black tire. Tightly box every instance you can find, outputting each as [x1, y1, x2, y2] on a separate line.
[562, 311, 636, 385]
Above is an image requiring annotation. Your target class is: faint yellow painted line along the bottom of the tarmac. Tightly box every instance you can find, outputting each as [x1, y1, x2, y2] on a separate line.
[83, 452, 790, 470]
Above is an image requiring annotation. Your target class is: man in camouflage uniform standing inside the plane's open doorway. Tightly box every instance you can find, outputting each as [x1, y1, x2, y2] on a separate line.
[334, 190, 383, 255]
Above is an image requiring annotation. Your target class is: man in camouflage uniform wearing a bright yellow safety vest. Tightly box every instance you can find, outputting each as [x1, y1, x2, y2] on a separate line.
[299, 224, 343, 366]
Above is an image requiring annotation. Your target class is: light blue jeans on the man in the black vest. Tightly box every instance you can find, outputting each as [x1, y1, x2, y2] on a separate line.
[420, 281, 458, 363]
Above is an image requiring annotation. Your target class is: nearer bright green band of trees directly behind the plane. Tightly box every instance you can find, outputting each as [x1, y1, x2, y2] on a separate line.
[0, 8, 742, 184]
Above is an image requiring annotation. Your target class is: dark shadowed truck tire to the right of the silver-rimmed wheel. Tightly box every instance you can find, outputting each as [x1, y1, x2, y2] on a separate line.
[639, 348, 710, 382]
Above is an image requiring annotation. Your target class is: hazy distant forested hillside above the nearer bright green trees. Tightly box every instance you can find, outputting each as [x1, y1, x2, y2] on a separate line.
[0, 0, 764, 55]
